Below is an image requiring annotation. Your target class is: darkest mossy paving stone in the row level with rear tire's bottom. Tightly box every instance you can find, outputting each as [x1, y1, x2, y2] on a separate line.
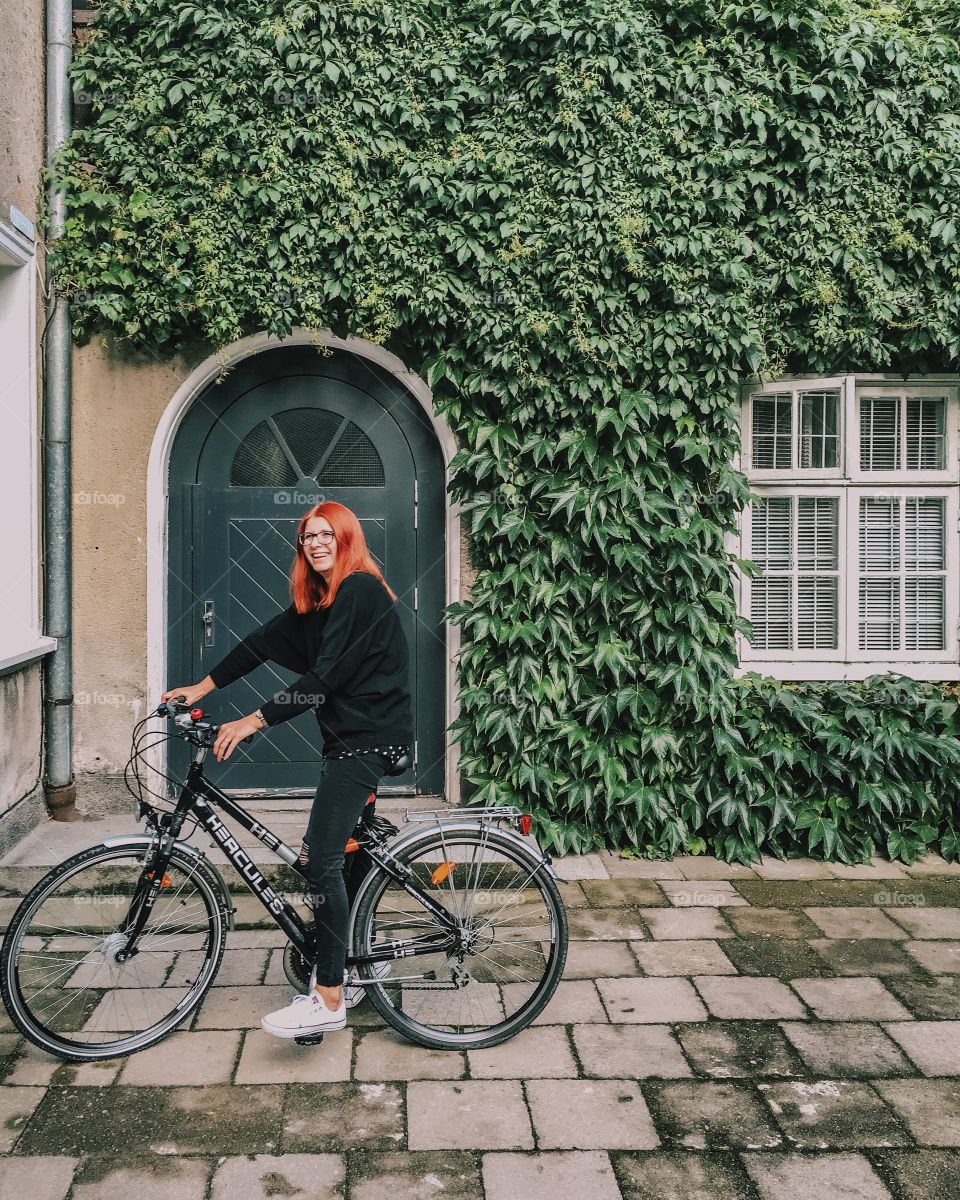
[677, 1021, 803, 1079]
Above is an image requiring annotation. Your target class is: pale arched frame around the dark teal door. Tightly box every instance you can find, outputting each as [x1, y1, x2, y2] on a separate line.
[146, 329, 461, 804]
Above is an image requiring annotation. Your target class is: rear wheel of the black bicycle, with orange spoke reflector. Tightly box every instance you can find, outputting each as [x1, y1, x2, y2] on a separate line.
[353, 826, 568, 1050]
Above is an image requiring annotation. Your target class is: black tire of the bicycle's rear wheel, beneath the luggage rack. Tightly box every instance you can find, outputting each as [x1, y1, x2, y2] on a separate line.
[352, 826, 569, 1050]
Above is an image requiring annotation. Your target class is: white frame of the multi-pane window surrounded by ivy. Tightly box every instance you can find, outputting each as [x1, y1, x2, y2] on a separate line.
[727, 373, 960, 680]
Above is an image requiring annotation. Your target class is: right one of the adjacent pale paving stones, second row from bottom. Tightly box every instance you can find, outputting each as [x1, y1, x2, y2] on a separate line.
[527, 1079, 660, 1150]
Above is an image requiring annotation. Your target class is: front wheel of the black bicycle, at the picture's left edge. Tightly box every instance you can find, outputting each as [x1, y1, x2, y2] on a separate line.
[0, 846, 226, 1062]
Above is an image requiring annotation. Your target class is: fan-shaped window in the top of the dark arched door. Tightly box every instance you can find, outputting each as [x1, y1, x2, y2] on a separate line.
[230, 408, 385, 487]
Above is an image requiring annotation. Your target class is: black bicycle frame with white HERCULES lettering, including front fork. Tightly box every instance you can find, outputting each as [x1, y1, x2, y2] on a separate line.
[139, 748, 457, 966]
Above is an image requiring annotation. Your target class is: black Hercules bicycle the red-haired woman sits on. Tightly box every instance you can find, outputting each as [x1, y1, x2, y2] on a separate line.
[0, 701, 568, 1062]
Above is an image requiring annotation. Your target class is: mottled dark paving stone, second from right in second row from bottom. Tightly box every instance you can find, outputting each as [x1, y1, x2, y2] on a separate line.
[757, 1079, 910, 1150]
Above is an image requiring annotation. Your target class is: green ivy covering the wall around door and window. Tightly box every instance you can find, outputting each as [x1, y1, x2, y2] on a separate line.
[48, 0, 960, 860]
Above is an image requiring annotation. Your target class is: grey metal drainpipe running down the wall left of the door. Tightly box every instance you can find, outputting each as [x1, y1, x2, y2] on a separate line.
[43, 0, 79, 821]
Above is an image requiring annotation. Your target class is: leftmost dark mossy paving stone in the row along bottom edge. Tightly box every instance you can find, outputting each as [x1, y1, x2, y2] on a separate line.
[348, 1150, 482, 1200]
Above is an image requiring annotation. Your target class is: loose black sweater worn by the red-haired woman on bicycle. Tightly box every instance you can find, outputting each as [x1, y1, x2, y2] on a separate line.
[210, 571, 414, 750]
